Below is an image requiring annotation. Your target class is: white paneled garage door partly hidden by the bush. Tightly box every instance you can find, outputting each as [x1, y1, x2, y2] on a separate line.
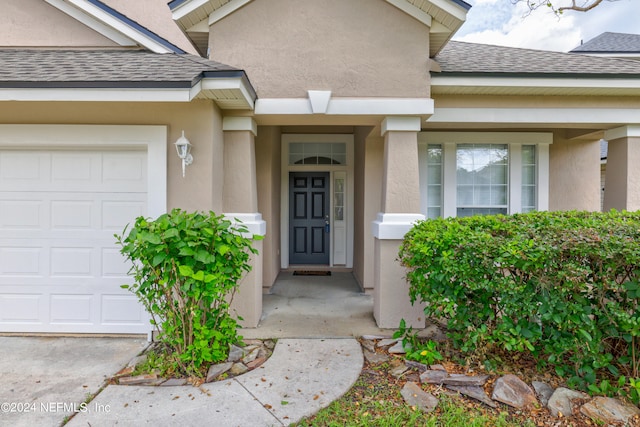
[0, 129, 165, 333]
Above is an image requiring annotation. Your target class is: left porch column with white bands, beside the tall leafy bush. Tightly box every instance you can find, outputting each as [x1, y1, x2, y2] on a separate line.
[222, 117, 266, 328]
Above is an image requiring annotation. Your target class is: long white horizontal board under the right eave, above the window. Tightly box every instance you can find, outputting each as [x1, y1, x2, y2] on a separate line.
[427, 107, 640, 124]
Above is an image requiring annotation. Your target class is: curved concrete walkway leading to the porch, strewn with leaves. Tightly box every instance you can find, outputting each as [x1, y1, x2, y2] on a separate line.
[67, 338, 363, 427]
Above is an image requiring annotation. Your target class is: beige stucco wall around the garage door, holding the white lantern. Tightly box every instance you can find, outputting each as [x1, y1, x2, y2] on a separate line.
[0, 101, 223, 213]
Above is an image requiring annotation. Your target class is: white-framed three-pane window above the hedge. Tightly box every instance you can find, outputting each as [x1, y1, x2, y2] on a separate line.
[418, 132, 552, 218]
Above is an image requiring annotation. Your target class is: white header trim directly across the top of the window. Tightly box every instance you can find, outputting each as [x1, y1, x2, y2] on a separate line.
[418, 131, 553, 144]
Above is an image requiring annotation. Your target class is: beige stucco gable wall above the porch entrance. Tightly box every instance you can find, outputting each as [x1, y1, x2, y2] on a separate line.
[209, 0, 429, 98]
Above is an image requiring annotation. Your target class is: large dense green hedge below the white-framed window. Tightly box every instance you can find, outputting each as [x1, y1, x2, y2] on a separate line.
[399, 211, 640, 394]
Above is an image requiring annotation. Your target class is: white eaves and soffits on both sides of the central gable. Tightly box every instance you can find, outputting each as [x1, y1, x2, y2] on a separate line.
[169, 0, 471, 57]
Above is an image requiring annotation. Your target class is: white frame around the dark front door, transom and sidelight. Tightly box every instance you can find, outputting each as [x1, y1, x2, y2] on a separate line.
[280, 134, 354, 268]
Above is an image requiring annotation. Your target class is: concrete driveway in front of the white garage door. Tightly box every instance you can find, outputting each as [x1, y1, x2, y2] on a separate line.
[0, 336, 147, 427]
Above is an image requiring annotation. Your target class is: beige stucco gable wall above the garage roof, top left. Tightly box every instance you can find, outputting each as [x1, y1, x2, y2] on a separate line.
[0, 0, 117, 47]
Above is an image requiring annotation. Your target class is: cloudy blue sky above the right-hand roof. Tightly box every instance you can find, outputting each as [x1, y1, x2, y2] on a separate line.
[453, 0, 640, 52]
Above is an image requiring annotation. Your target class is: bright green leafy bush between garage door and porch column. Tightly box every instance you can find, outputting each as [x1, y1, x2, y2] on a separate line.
[115, 209, 257, 376]
